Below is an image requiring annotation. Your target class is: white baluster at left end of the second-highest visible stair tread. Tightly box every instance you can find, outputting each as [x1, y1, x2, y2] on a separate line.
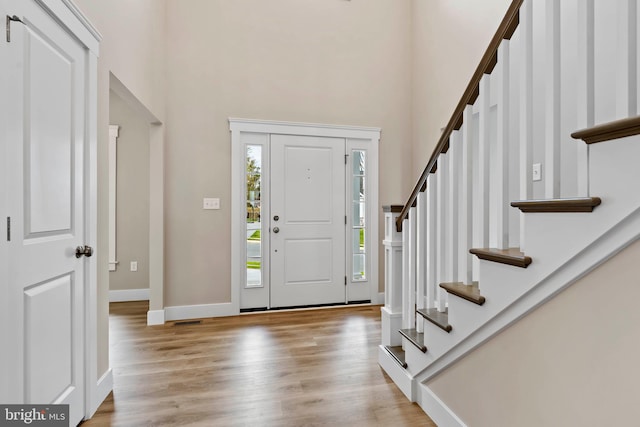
[518, 0, 533, 251]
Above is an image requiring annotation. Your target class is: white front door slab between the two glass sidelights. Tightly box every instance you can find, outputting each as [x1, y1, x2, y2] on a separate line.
[270, 135, 345, 307]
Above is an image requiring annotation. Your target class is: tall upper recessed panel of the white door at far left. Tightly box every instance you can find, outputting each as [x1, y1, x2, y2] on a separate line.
[24, 31, 74, 235]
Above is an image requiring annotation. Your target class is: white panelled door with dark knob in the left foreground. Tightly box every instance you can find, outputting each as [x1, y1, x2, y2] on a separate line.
[2, 1, 89, 425]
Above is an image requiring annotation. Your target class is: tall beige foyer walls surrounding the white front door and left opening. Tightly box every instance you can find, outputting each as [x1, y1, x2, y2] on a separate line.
[76, 0, 509, 373]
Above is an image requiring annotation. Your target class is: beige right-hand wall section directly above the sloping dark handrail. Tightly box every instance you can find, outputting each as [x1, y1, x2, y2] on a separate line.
[411, 0, 511, 181]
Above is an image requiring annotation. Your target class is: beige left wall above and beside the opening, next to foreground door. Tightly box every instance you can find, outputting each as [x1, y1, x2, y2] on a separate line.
[74, 0, 165, 377]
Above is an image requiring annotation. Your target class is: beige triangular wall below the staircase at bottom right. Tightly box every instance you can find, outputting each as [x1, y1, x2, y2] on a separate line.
[429, 241, 640, 427]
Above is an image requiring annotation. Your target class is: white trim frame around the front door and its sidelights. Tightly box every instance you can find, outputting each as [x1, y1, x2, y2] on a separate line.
[229, 118, 381, 313]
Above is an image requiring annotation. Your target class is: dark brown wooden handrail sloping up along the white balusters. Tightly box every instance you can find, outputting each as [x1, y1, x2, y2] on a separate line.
[396, 0, 524, 232]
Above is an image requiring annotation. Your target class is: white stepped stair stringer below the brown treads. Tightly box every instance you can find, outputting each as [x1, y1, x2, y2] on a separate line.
[396, 136, 640, 425]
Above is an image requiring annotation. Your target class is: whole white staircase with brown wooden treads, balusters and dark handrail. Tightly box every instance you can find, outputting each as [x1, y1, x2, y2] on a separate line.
[379, 0, 640, 426]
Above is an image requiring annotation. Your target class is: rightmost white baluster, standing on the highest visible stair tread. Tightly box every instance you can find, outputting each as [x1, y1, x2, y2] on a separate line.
[616, 0, 638, 119]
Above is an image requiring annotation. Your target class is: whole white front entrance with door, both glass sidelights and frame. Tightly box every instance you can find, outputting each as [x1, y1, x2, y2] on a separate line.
[230, 119, 380, 311]
